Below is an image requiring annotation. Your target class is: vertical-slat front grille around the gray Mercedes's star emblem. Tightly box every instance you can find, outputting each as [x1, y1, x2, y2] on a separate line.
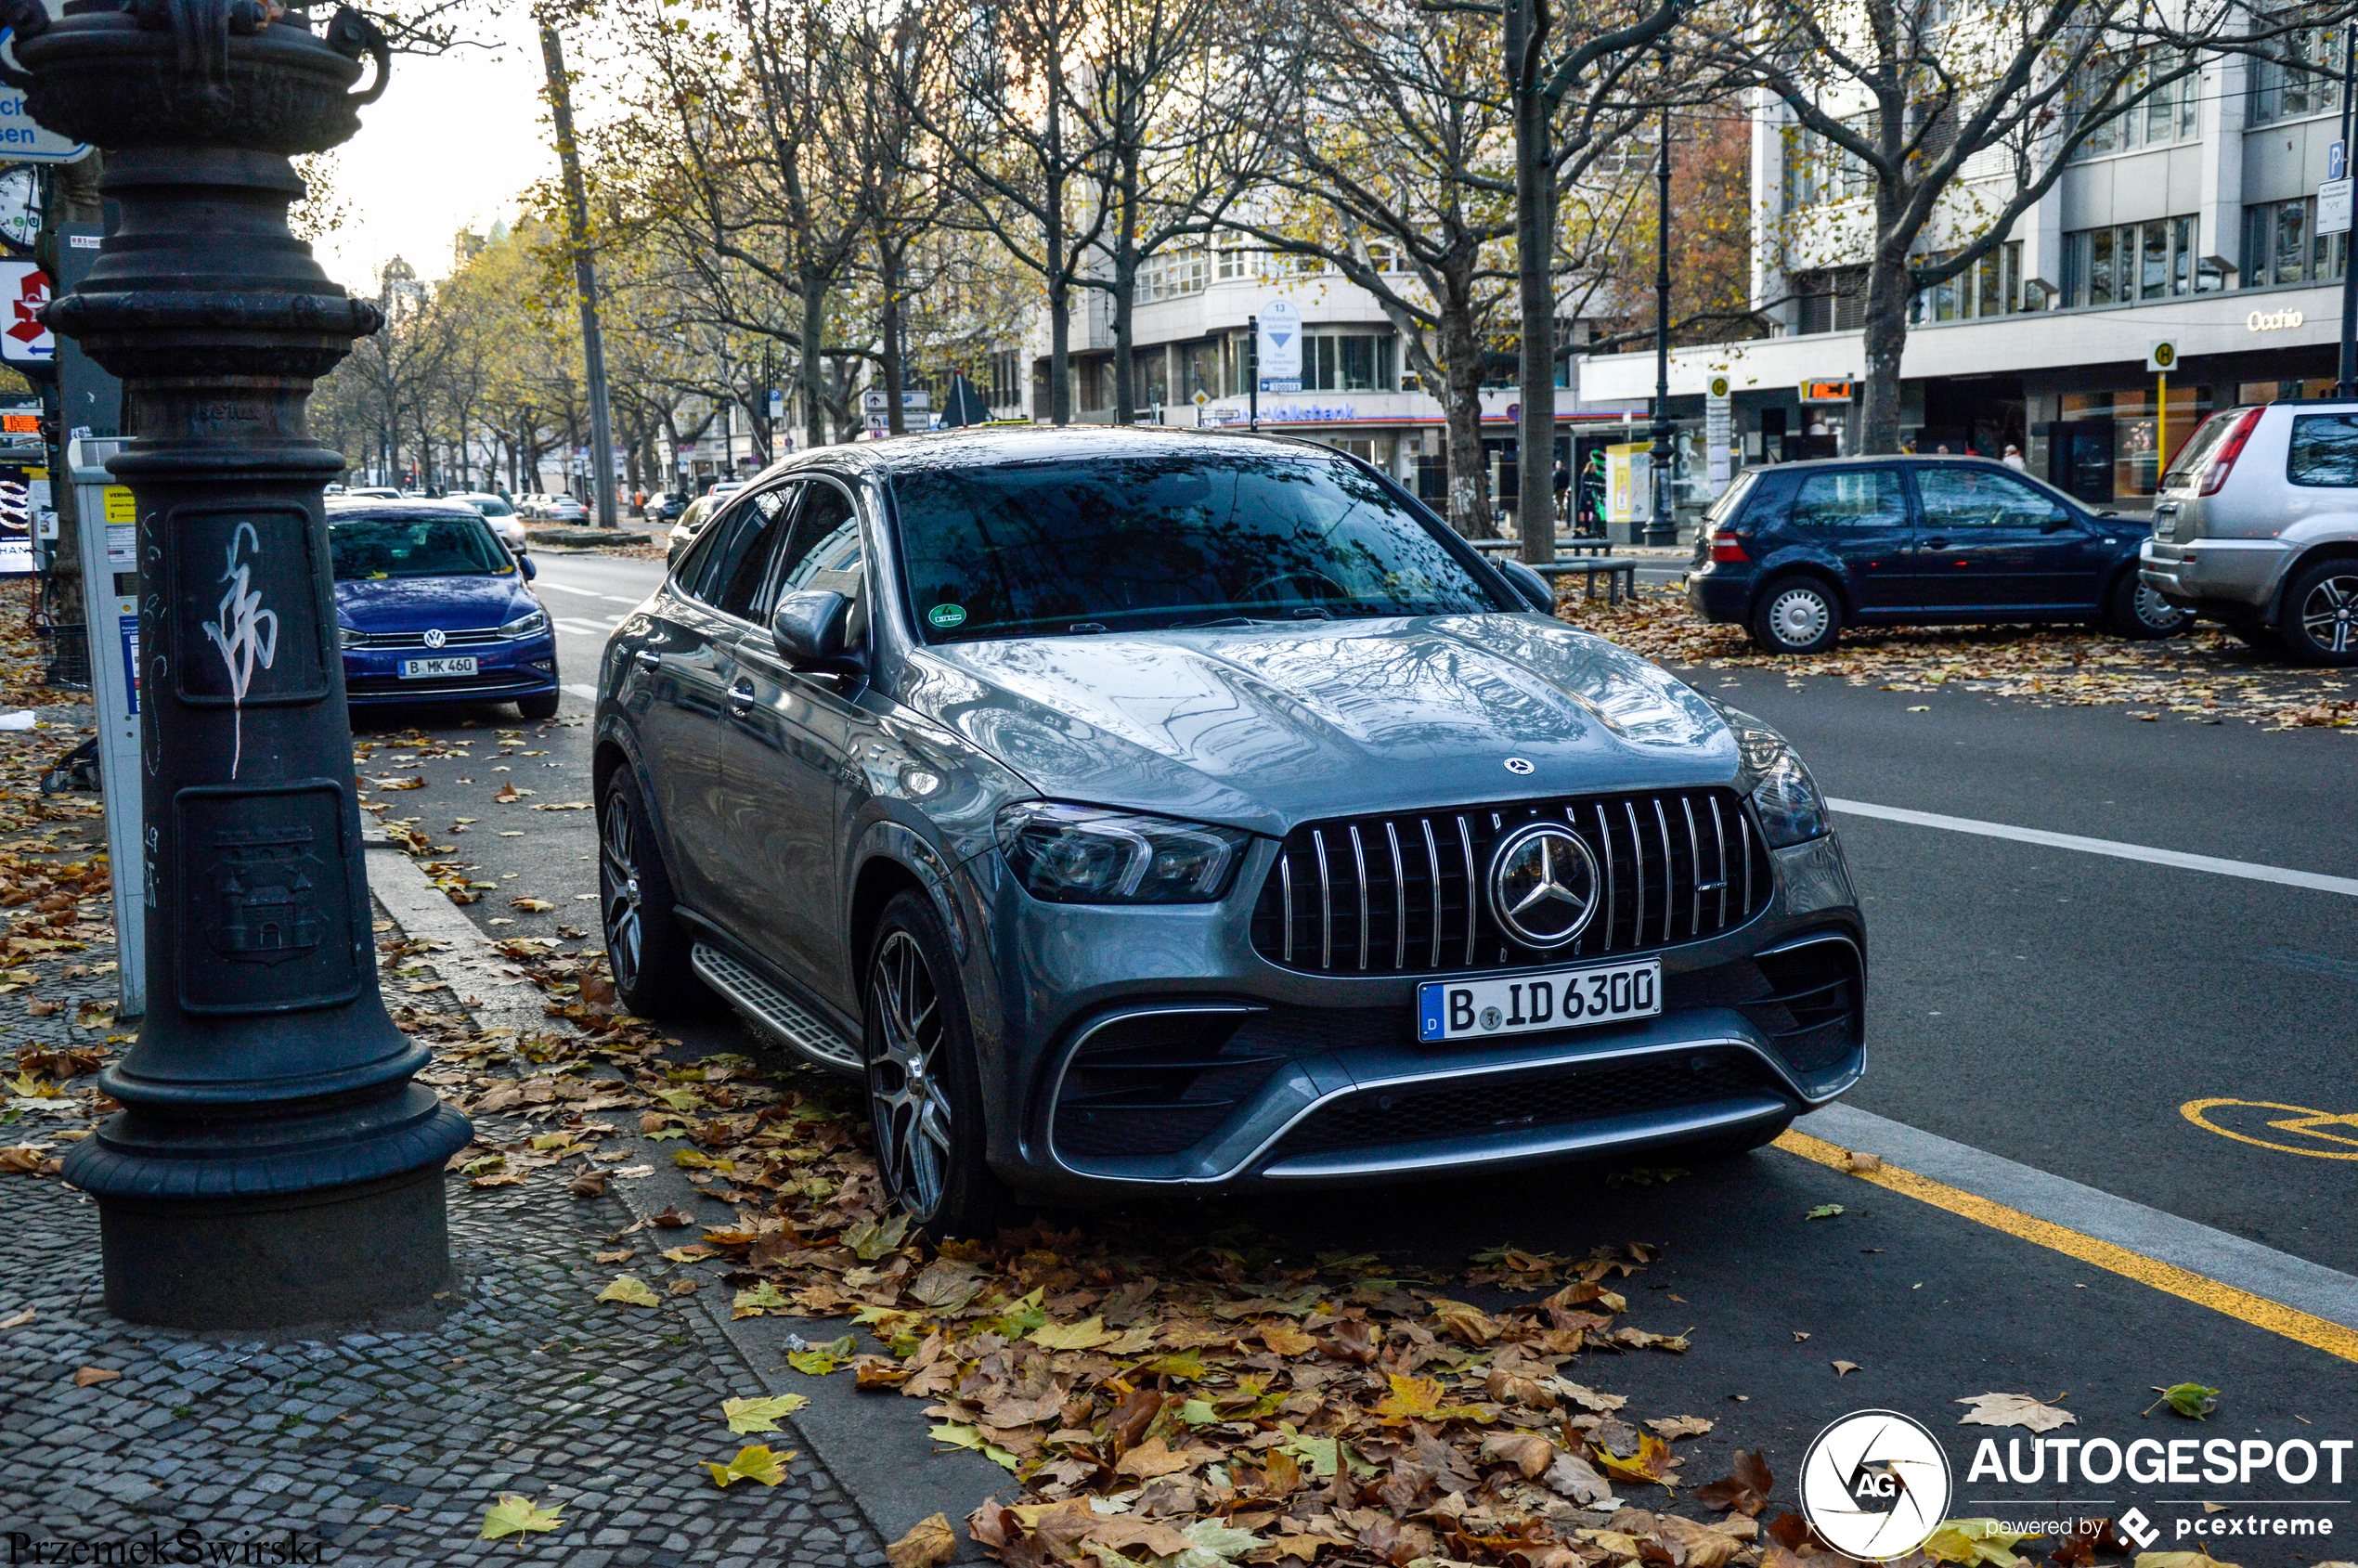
[1252, 790, 1771, 974]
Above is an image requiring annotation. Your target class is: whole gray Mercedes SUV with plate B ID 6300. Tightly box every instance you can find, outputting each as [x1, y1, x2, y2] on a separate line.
[597, 429, 1865, 1236]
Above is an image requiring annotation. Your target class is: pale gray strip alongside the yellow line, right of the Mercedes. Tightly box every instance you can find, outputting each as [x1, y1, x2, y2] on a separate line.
[1794, 1104, 2358, 1328]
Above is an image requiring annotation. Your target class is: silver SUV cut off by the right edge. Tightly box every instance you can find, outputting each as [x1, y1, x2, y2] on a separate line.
[2136, 401, 2358, 665]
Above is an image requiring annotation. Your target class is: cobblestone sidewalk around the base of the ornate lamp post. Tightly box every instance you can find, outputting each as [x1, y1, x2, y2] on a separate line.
[0, 1176, 885, 1568]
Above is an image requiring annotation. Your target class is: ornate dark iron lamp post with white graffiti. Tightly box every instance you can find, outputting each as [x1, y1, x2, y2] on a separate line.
[26, 0, 472, 1329]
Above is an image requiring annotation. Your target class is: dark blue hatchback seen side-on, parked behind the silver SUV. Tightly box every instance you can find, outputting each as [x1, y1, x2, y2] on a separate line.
[1686, 458, 2193, 654]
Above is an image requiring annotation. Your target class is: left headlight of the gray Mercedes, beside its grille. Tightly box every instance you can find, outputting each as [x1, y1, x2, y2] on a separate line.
[1000, 799, 1252, 903]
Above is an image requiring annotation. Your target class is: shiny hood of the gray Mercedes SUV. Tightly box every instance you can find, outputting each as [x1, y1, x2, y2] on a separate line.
[899, 616, 1738, 835]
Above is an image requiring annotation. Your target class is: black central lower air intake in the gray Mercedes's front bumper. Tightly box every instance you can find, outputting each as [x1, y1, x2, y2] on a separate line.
[1274, 1052, 1785, 1160]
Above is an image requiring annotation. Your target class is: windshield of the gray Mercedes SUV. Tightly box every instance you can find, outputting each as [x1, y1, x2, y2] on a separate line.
[894, 453, 1499, 641]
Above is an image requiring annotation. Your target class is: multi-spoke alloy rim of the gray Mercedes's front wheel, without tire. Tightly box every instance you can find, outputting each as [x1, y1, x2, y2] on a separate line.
[868, 931, 952, 1224]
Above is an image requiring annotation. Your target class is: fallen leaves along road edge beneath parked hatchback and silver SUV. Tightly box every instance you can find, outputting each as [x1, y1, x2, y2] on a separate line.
[1556, 585, 2358, 733]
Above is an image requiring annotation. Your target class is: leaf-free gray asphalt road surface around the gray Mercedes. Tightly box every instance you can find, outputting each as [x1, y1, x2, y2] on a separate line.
[343, 554, 2358, 1568]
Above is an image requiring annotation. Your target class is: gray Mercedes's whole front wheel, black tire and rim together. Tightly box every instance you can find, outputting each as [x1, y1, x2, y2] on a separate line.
[861, 889, 1014, 1240]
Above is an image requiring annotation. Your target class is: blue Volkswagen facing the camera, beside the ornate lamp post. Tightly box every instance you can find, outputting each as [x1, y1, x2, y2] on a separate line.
[328, 499, 556, 719]
